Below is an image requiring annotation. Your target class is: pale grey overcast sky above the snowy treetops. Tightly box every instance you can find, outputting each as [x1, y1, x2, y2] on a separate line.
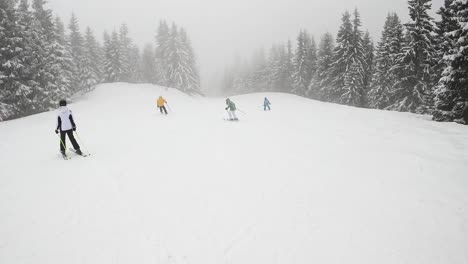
[49, 0, 443, 94]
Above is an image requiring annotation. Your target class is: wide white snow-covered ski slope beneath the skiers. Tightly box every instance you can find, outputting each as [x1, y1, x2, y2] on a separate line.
[0, 84, 468, 264]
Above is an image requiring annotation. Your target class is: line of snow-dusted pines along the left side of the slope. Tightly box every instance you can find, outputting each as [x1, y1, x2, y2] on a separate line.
[0, 0, 200, 121]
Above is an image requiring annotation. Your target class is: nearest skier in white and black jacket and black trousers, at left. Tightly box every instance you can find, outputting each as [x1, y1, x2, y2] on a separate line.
[55, 100, 83, 155]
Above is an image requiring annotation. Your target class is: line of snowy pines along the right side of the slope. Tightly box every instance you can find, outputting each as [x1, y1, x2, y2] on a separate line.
[222, 0, 468, 121]
